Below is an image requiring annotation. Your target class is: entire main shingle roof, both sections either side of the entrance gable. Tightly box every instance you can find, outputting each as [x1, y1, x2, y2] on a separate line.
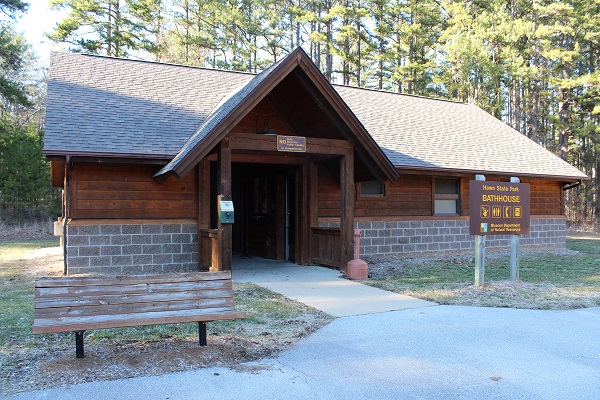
[44, 53, 587, 180]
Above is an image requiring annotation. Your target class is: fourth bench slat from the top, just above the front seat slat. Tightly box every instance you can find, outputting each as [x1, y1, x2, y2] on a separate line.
[35, 297, 234, 319]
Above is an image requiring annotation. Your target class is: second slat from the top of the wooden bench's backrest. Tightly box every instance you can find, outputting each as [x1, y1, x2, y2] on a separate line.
[35, 280, 231, 298]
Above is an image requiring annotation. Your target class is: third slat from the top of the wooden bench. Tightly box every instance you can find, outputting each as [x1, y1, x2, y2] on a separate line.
[35, 289, 233, 312]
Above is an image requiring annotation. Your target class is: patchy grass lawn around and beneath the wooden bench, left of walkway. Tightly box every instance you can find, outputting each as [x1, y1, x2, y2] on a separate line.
[0, 241, 333, 396]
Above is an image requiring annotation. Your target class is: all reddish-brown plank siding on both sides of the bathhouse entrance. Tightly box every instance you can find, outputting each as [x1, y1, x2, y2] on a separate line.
[64, 161, 563, 222]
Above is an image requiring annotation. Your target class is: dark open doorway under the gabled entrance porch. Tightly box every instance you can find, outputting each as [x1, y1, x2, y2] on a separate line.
[232, 163, 298, 261]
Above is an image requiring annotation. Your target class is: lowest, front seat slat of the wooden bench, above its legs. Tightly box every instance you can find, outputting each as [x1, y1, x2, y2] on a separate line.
[33, 308, 246, 334]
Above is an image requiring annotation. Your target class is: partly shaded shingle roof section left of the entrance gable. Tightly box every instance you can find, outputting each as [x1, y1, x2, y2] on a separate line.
[44, 53, 254, 159]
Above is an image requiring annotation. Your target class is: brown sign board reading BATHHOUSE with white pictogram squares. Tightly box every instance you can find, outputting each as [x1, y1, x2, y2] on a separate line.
[469, 181, 529, 236]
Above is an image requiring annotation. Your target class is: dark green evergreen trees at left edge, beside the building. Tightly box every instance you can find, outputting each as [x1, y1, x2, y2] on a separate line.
[0, 0, 60, 223]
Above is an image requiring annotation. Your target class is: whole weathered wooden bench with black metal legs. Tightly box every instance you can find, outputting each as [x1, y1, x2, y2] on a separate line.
[33, 271, 246, 358]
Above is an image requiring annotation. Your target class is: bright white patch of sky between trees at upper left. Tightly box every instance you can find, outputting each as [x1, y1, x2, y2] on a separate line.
[17, 0, 65, 66]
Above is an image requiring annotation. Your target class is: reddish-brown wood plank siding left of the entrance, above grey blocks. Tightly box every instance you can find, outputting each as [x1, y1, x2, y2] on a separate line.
[70, 163, 198, 220]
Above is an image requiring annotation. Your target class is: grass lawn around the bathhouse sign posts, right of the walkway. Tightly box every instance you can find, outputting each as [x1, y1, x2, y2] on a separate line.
[365, 236, 600, 309]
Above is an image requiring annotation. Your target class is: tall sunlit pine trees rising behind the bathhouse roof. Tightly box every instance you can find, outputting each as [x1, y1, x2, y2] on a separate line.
[19, 0, 600, 223]
